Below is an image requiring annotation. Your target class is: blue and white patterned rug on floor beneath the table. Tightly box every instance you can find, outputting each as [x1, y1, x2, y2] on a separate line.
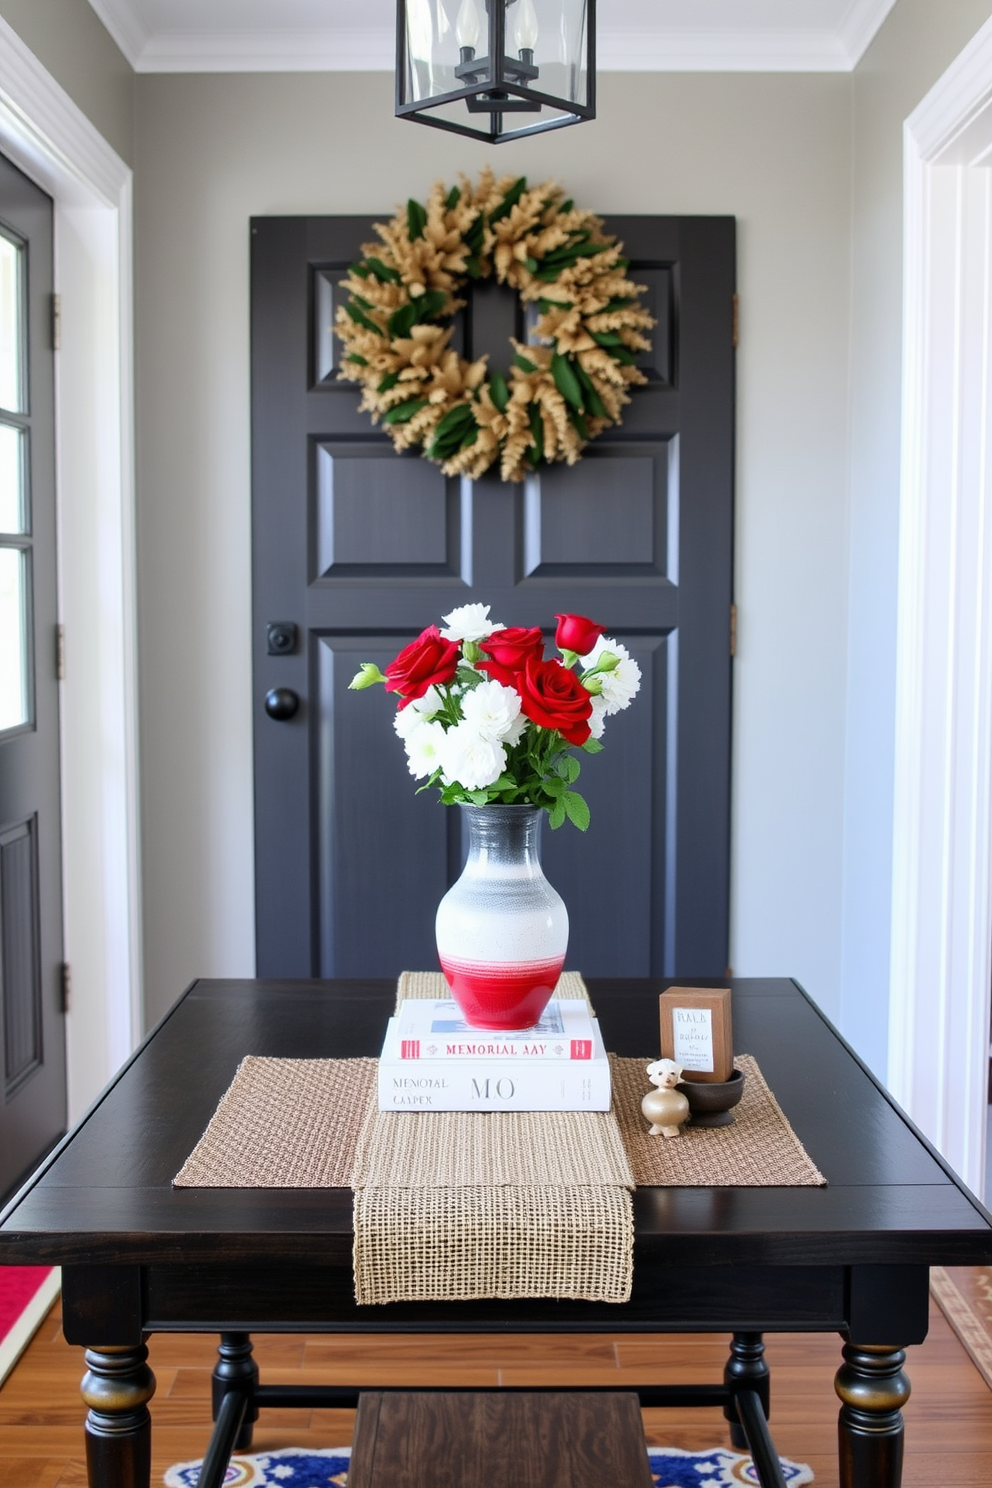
[165, 1446, 814, 1488]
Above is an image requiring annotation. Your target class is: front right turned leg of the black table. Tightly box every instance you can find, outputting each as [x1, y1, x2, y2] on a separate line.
[834, 1344, 910, 1488]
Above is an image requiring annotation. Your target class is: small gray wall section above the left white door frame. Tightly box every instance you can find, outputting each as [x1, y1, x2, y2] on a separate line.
[0, 0, 134, 165]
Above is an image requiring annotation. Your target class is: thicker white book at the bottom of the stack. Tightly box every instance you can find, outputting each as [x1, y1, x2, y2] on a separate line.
[378, 1018, 611, 1112]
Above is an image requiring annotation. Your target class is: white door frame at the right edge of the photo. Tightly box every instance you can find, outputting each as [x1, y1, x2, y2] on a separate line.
[889, 11, 992, 1195]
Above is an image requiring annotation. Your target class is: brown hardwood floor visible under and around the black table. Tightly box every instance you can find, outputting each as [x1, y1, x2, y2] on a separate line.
[0, 1305, 992, 1488]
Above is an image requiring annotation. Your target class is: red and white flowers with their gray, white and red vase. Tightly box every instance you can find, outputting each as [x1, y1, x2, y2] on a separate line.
[351, 604, 641, 1028]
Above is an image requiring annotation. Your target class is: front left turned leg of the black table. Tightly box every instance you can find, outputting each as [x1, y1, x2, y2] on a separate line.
[80, 1344, 155, 1488]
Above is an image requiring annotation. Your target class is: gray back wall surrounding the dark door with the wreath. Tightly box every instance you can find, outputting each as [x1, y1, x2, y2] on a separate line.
[137, 74, 851, 1035]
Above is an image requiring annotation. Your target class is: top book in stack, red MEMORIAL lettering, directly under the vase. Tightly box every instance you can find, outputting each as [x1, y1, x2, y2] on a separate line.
[396, 997, 595, 1061]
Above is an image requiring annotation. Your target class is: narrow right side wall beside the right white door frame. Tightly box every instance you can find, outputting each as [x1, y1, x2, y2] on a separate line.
[842, 0, 992, 1070]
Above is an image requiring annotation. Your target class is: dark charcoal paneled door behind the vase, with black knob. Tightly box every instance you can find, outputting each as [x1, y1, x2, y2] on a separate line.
[251, 217, 735, 976]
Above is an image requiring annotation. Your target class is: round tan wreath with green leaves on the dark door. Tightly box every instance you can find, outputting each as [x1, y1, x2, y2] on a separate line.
[335, 167, 654, 481]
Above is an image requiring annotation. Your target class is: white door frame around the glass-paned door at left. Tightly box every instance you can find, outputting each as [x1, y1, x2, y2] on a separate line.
[0, 18, 141, 1117]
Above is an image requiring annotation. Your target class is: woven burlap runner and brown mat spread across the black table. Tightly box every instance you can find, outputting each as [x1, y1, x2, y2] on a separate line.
[174, 972, 825, 1303]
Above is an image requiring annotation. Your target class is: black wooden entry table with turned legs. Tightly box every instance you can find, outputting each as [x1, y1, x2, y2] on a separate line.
[0, 979, 992, 1488]
